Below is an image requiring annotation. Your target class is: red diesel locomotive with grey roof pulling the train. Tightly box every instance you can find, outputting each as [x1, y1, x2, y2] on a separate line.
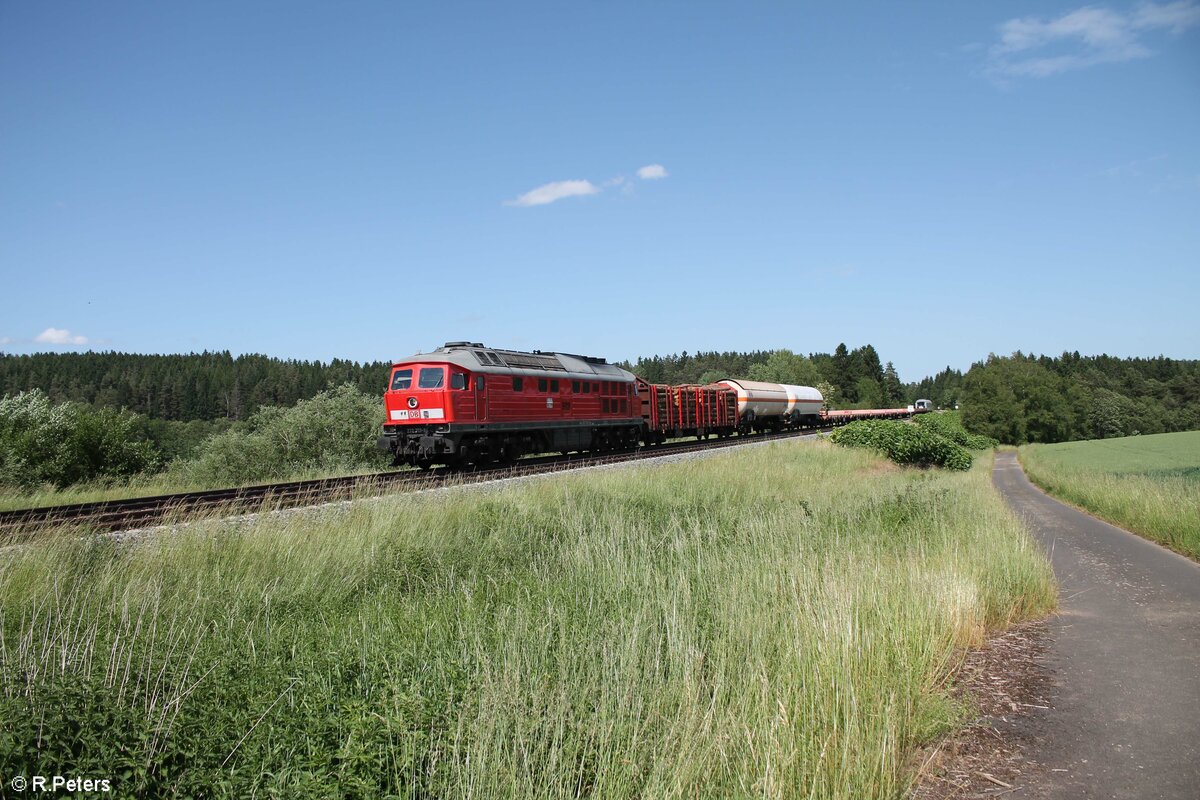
[378, 342, 642, 467]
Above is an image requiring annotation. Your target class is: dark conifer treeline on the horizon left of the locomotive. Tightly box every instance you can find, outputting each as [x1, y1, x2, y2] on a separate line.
[0, 351, 391, 422]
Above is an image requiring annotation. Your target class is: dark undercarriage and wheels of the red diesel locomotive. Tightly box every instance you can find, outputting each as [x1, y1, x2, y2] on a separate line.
[378, 422, 641, 469]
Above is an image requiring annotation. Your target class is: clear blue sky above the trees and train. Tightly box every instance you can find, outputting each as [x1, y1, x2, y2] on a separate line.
[0, 0, 1200, 380]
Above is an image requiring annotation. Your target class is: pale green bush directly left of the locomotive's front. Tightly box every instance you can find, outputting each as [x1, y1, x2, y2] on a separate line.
[173, 384, 390, 486]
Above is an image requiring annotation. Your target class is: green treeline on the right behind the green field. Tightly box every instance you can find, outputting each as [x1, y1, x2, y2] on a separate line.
[958, 351, 1200, 444]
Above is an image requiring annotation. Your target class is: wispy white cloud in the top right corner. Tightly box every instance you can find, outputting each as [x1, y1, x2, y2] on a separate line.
[986, 0, 1200, 78]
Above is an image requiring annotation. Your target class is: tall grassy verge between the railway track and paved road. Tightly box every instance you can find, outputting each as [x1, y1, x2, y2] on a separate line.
[0, 443, 1055, 798]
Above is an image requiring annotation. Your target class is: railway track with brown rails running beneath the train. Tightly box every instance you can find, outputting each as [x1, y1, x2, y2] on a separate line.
[0, 426, 833, 534]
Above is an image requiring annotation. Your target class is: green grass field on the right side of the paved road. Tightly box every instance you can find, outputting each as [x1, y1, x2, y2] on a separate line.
[1020, 431, 1200, 559]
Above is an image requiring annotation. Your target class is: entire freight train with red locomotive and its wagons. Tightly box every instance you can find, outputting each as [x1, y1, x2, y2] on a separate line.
[378, 342, 914, 468]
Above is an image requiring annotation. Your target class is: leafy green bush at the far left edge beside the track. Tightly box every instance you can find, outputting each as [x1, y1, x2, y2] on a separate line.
[0, 389, 155, 489]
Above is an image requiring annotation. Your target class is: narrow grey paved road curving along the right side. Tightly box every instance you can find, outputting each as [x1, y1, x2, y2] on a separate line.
[992, 452, 1200, 800]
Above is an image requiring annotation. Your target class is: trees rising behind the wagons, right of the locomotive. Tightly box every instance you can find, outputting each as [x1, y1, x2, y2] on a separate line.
[618, 343, 917, 408]
